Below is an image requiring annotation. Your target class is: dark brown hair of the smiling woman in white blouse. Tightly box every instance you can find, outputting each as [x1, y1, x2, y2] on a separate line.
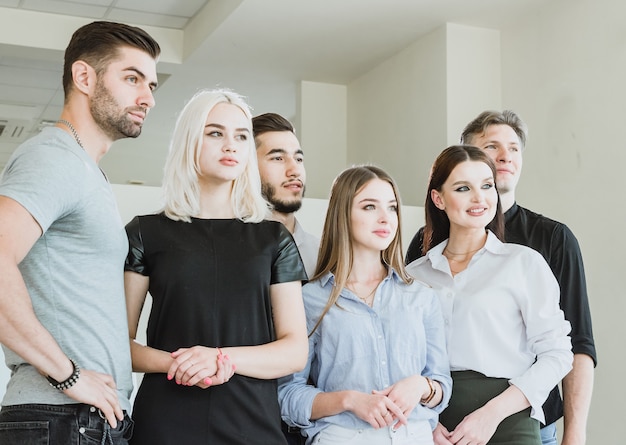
[422, 145, 504, 255]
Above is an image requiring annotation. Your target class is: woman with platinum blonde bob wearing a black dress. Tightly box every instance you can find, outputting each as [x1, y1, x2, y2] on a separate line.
[125, 90, 307, 445]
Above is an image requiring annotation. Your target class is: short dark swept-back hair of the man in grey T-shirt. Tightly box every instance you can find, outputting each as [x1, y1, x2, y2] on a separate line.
[63, 21, 161, 99]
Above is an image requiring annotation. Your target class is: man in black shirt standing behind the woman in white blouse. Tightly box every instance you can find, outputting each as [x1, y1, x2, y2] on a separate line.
[406, 110, 597, 445]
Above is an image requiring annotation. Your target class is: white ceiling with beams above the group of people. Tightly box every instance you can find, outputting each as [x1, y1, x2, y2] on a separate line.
[0, 0, 542, 185]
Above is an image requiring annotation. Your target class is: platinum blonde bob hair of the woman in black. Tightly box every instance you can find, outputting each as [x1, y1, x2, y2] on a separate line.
[163, 89, 269, 222]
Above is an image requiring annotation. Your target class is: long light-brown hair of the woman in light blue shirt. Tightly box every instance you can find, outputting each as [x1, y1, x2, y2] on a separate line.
[311, 165, 413, 333]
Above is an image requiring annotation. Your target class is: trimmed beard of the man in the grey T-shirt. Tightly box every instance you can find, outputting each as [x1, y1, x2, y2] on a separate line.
[89, 79, 145, 141]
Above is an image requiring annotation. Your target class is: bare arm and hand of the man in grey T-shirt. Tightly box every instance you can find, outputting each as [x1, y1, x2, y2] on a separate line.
[0, 196, 123, 427]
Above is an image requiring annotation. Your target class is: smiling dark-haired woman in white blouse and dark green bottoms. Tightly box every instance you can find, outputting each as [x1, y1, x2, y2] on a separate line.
[407, 145, 573, 445]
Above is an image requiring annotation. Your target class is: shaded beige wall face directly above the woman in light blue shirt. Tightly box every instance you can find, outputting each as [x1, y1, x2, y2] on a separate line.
[348, 23, 446, 205]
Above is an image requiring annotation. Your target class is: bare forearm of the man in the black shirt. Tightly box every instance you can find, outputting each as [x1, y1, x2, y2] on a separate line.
[561, 354, 594, 445]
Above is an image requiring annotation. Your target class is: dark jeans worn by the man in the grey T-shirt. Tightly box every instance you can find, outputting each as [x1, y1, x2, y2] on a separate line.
[0, 404, 133, 445]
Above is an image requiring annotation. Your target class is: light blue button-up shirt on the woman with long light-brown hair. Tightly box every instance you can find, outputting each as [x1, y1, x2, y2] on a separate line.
[278, 271, 452, 437]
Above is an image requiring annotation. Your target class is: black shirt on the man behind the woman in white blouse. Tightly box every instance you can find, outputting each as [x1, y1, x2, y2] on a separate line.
[405, 203, 597, 425]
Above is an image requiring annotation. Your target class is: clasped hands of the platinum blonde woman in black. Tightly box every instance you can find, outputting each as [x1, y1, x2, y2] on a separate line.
[167, 346, 236, 389]
